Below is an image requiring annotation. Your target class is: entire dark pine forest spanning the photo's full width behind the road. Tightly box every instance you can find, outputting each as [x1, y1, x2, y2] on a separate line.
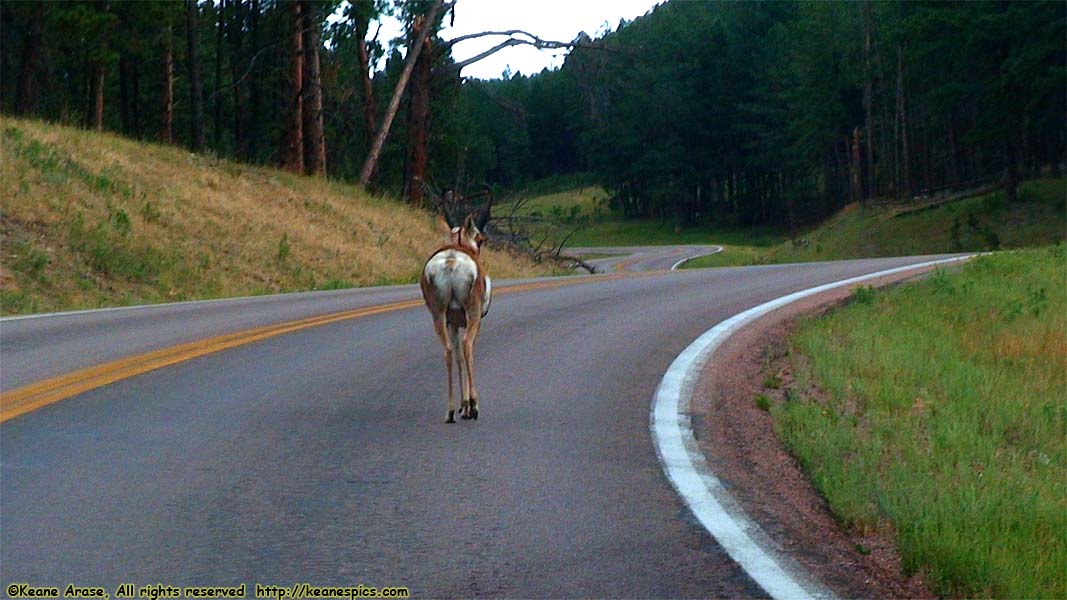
[0, 0, 1067, 224]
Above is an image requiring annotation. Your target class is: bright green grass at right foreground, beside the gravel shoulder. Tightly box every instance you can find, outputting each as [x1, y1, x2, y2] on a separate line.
[773, 243, 1067, 598]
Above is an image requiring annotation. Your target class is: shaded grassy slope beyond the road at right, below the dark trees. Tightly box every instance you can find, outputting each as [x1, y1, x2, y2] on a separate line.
[685, 179, 1067, 268]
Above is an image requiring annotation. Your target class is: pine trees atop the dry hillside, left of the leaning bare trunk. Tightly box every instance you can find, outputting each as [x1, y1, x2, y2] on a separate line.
[0, 0, 433, 178]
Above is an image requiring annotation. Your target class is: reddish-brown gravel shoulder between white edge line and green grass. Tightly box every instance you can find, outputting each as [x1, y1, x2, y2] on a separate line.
[691, 263, 936, 598]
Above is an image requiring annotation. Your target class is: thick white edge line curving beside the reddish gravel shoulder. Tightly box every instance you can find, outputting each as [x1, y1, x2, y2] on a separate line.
[650, 254, 974, 600]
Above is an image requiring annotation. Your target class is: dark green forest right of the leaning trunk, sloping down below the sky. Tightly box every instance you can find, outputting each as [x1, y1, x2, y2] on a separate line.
[465, 1, 1067, 224]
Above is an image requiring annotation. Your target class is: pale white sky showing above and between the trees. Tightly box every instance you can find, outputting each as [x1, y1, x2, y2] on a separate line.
[371, 0, 664, 79]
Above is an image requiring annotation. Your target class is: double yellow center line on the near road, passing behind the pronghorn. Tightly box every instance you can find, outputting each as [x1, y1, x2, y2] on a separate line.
[0, 271, 633, 423]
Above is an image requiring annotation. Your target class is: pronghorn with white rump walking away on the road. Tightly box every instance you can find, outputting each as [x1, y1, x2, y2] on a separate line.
[418, 196, 493, 423]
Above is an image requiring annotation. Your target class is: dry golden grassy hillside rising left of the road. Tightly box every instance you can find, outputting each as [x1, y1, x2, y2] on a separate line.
[0, 117, 563, 314]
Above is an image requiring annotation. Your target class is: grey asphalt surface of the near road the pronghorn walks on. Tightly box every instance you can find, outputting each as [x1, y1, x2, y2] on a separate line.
[0, 257, 951, 598]
